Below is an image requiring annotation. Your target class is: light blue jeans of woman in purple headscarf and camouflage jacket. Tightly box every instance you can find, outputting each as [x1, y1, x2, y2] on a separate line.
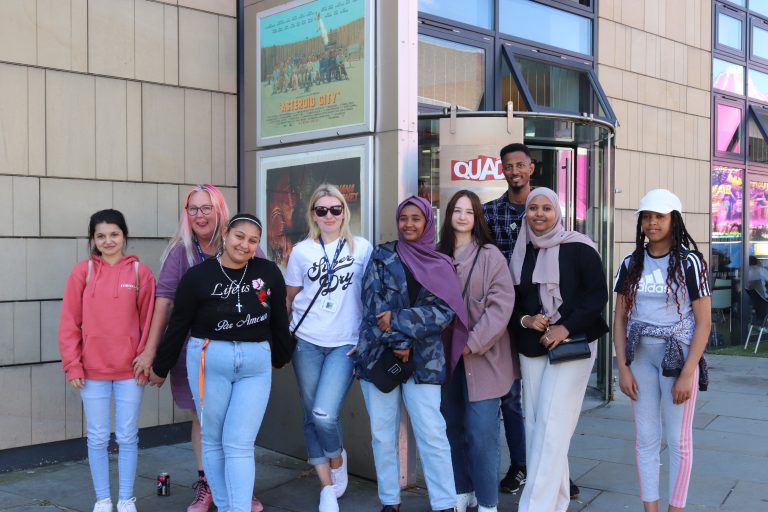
[360, 378, 456, 510]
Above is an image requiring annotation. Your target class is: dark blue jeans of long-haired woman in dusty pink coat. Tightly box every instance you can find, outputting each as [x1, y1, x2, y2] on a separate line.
[440, 361, 500, 508]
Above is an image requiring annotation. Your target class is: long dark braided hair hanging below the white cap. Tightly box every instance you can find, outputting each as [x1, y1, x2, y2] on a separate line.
[621, 210, 707, 319]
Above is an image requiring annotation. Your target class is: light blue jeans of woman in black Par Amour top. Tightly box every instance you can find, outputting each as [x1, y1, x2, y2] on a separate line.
[187, 338, 272, 512]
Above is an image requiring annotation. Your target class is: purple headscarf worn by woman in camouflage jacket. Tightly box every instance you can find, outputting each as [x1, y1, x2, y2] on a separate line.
[396, 196, 469, 378]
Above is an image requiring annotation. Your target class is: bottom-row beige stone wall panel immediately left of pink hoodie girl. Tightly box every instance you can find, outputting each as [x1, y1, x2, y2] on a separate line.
[32, 363, 68, 444]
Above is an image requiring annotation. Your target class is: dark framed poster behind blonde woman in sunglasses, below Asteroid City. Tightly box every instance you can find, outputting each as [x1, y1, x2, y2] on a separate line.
[256, 137, 373, 271]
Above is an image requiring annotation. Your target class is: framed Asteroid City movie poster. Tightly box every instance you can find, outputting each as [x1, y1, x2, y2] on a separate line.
[256, 0, 373, 147]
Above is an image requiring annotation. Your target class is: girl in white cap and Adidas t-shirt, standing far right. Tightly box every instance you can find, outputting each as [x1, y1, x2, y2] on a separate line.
[613, 189, 712, 512]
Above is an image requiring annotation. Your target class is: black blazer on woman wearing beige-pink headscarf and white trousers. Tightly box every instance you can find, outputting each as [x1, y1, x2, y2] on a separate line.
[509, 242, 608, 357]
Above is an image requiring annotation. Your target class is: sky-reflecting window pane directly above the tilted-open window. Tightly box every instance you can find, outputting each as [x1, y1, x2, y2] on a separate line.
[499, 0, 592, 55]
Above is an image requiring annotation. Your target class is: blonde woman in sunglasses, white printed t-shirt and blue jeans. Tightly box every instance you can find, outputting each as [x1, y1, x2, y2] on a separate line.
[285, 184, 372, 512]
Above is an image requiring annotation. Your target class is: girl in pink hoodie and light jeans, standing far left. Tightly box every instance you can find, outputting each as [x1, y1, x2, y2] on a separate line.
[59, 210, 155, 512]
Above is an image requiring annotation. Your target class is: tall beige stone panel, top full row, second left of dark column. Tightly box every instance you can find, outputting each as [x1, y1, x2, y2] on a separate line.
[179, 8, 219, 90]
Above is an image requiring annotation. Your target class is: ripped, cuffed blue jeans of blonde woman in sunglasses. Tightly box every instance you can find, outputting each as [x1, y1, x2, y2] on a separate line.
[293, 338, 354, 466]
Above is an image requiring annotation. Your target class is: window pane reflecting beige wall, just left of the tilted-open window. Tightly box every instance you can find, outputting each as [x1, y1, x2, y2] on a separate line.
[418, 34, 485, 110]
